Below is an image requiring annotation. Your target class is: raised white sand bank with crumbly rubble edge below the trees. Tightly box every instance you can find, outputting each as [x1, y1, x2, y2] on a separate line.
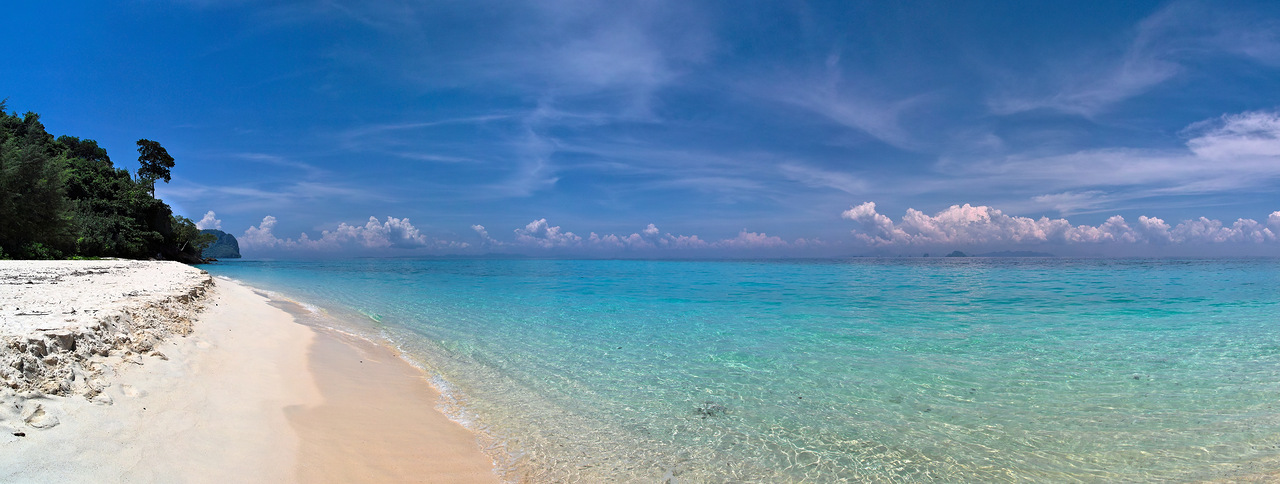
[0, 260, 212, 428]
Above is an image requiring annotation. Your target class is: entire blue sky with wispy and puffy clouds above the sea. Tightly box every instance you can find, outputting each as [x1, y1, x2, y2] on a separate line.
[0, 0, 1280, 257]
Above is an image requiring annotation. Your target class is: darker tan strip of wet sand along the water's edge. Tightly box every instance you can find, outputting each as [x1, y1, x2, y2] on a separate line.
[269, 300, 498, 483]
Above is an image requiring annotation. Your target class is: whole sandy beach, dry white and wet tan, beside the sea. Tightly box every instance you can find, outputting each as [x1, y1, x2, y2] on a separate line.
[0, 261, 497, 483]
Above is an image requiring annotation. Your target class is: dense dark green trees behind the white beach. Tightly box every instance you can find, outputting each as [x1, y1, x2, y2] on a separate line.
[0, 100, 216, 264]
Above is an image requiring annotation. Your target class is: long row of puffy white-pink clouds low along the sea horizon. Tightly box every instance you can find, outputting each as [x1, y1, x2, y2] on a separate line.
[225, 202, 1280, 256]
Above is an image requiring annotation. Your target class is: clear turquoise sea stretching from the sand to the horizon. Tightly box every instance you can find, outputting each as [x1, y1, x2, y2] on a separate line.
[206, 259, 1280, 483]
